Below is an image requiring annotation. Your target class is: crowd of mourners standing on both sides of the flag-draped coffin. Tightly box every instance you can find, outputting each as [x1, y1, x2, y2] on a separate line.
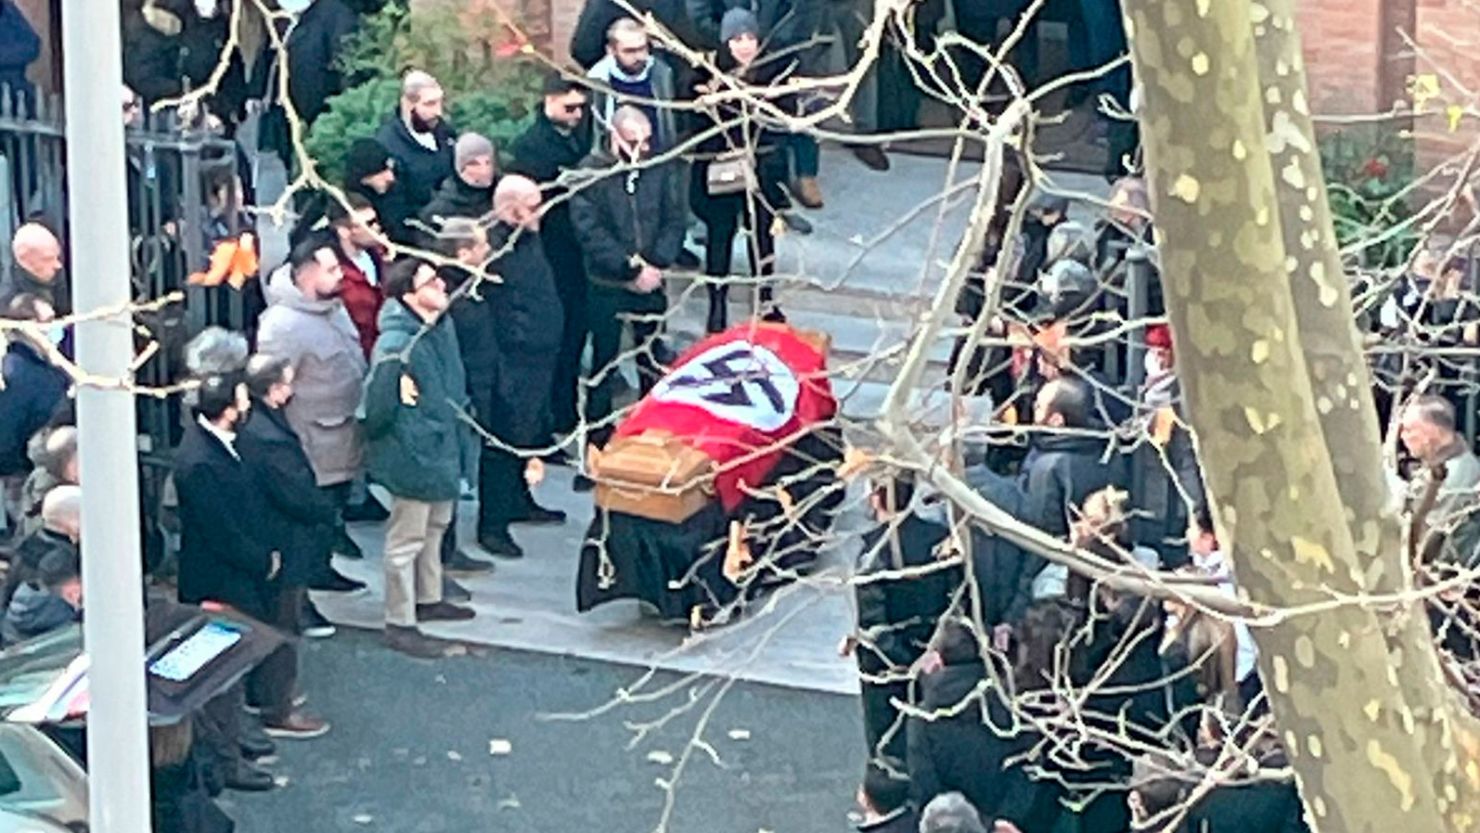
[0, 0, 1480, 833]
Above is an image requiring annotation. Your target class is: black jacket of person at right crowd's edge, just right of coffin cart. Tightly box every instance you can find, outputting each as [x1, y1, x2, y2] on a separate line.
[854, 515, 962, 673]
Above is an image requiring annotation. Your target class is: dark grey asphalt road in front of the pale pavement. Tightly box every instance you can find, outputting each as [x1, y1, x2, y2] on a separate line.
[223, 629, 863, 833]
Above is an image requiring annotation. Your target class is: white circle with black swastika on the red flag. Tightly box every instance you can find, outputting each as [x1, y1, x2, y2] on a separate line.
[648, 342, 802, 432]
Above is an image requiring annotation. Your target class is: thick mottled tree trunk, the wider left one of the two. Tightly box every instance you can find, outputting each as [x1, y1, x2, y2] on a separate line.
[1125, 0, 1471, 833]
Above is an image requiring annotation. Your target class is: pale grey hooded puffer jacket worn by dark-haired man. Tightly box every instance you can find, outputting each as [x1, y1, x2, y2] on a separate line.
[258, 266, 366, 485]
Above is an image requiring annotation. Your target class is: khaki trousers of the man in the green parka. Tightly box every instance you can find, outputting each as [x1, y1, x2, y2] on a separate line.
[385, 497, 453, 627]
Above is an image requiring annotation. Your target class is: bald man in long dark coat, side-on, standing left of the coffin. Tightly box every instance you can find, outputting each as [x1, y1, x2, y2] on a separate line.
[453, 176, 565, 558]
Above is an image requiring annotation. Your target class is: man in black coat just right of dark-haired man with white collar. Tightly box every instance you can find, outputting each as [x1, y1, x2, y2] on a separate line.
[238, 355, 347, 636]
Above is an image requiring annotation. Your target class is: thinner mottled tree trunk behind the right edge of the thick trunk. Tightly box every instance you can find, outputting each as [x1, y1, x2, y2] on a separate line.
[1254, 0, 1480, 822]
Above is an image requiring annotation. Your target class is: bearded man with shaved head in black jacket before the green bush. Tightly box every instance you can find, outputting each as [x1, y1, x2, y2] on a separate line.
[376, 70, 456, 216]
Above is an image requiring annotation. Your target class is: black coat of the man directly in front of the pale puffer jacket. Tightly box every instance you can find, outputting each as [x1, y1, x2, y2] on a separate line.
[237, 399, 337, 586]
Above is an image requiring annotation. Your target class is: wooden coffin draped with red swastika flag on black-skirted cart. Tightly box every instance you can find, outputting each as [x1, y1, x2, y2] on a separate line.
[576, 323, 842, 621]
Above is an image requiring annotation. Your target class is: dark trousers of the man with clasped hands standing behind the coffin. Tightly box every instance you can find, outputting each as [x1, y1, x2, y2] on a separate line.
[585, 286, 667, 445]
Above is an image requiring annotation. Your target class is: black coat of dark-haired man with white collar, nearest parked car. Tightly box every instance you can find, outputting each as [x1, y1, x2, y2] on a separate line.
[175, 420, 272, 618]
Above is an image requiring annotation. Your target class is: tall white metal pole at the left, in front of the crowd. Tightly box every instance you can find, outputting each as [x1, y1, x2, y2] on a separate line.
[62, 0, 149, 833]
